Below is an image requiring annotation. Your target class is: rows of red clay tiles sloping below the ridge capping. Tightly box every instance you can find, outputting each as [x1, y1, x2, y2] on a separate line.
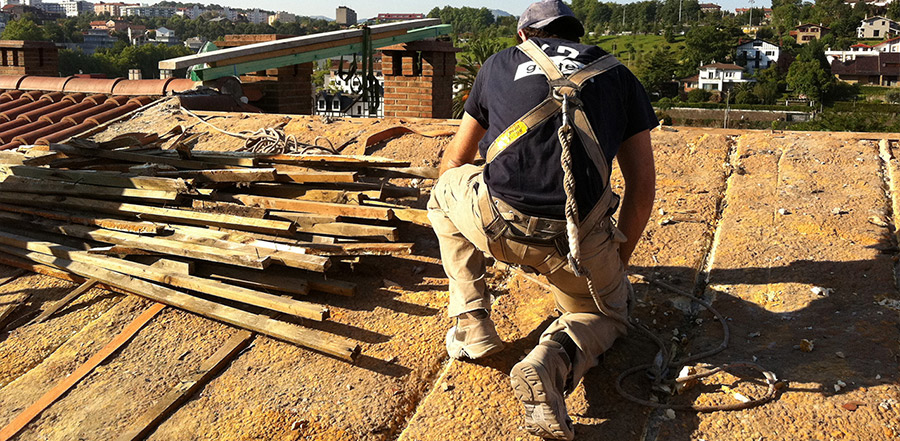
[0, 88, 154, 150]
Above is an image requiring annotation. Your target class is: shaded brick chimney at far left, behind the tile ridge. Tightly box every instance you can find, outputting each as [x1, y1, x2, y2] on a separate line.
[0, 40, 59, 77]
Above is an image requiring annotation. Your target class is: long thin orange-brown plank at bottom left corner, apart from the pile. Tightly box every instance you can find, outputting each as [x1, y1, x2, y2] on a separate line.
[0, 303, 165, 441]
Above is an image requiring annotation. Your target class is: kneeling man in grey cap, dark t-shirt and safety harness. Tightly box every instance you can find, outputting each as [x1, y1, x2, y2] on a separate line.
[428, 0, 658, 439]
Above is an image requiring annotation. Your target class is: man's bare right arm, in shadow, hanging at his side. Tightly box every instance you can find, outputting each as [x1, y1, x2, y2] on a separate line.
[616, 130, 656, 268]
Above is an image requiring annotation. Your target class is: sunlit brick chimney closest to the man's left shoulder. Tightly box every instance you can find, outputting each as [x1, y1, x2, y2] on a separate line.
[381, 41, 460, 118]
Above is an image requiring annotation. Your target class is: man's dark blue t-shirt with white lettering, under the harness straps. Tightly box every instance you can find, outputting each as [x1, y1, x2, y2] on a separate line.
[465, 38, 659, 219]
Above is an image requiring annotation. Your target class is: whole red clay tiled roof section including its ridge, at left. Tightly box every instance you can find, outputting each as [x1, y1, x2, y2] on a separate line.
[0, 75, 195, 150]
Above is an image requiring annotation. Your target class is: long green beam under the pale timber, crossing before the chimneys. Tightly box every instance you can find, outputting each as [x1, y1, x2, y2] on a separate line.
[191, 24, 452, 81]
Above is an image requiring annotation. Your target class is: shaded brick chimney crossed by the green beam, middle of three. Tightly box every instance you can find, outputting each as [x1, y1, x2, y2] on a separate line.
[215, 34, 313, 115]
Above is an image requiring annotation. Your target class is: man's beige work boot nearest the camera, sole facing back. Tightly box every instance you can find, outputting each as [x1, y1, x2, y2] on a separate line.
[509, 340, 575, 440]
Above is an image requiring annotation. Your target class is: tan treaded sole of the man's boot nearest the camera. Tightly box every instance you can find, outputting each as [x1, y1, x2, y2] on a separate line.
[509, 361, 575, 440]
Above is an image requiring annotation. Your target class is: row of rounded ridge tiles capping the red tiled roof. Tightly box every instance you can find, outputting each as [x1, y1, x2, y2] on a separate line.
[0, 75, 197, 96]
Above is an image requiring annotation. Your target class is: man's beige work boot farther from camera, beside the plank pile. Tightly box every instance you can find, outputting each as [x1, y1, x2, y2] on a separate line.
[447, 309, 503, 360]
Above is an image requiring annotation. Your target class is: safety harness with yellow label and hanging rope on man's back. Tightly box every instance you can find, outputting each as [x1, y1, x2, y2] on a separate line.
[485, 40, 621, 312]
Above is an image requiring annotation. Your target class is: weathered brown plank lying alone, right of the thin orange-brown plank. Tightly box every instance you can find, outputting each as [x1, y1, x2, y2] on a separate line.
[117, 331, 256, 441]
